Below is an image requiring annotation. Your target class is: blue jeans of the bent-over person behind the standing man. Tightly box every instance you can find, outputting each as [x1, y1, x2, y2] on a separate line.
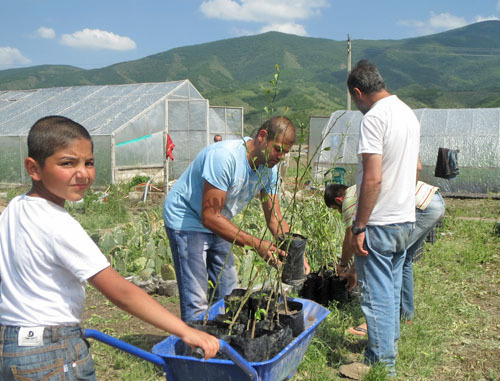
[401, 192, 444, 320]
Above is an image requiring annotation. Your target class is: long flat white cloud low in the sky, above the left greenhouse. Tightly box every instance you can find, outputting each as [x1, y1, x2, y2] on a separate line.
[61, 28, 136, 50]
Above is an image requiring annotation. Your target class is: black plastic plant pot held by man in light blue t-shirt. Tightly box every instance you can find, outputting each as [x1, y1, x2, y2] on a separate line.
[278, 233, 307, 286]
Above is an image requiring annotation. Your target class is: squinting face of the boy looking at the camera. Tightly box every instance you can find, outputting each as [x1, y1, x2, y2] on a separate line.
[27, 139, 95, 207]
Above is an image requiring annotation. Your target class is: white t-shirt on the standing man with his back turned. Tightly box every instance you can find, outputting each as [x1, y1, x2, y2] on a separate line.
[356, 95, 420, 225]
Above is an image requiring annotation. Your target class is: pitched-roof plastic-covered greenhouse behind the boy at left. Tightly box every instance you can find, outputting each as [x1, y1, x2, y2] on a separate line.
[0, 80, 243, 185]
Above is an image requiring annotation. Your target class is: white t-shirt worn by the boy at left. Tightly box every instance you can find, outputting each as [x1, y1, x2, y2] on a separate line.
[0, 195, 109, 327]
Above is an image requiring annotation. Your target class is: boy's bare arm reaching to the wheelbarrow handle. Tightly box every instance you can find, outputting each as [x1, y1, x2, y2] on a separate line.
[88, 267, 219, 359]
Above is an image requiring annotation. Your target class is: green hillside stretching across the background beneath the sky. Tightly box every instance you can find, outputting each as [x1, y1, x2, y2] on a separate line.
[0, 21, 500, 126]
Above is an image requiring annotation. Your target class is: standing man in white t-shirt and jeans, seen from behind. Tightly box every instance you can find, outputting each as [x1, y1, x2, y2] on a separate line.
[340, 60, 420, 376]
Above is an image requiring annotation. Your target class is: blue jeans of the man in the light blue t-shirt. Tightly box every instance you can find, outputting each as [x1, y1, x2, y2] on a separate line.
[166, 227, 238, 321]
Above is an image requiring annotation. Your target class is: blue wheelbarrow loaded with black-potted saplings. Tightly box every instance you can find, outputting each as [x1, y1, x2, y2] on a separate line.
[85, 298, 330, 381]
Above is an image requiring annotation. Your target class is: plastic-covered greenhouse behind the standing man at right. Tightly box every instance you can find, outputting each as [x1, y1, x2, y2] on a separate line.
[309, 108, 500, 194]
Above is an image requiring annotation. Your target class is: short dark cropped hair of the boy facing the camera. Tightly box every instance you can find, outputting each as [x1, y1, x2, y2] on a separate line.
[28, 115, 94, 167]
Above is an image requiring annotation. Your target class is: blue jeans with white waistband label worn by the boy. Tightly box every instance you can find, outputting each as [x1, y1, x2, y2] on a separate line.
[0, 325, 96, 381]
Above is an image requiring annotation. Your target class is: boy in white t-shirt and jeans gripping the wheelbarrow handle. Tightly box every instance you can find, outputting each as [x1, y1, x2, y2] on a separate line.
[0, 116, 219, 381]
